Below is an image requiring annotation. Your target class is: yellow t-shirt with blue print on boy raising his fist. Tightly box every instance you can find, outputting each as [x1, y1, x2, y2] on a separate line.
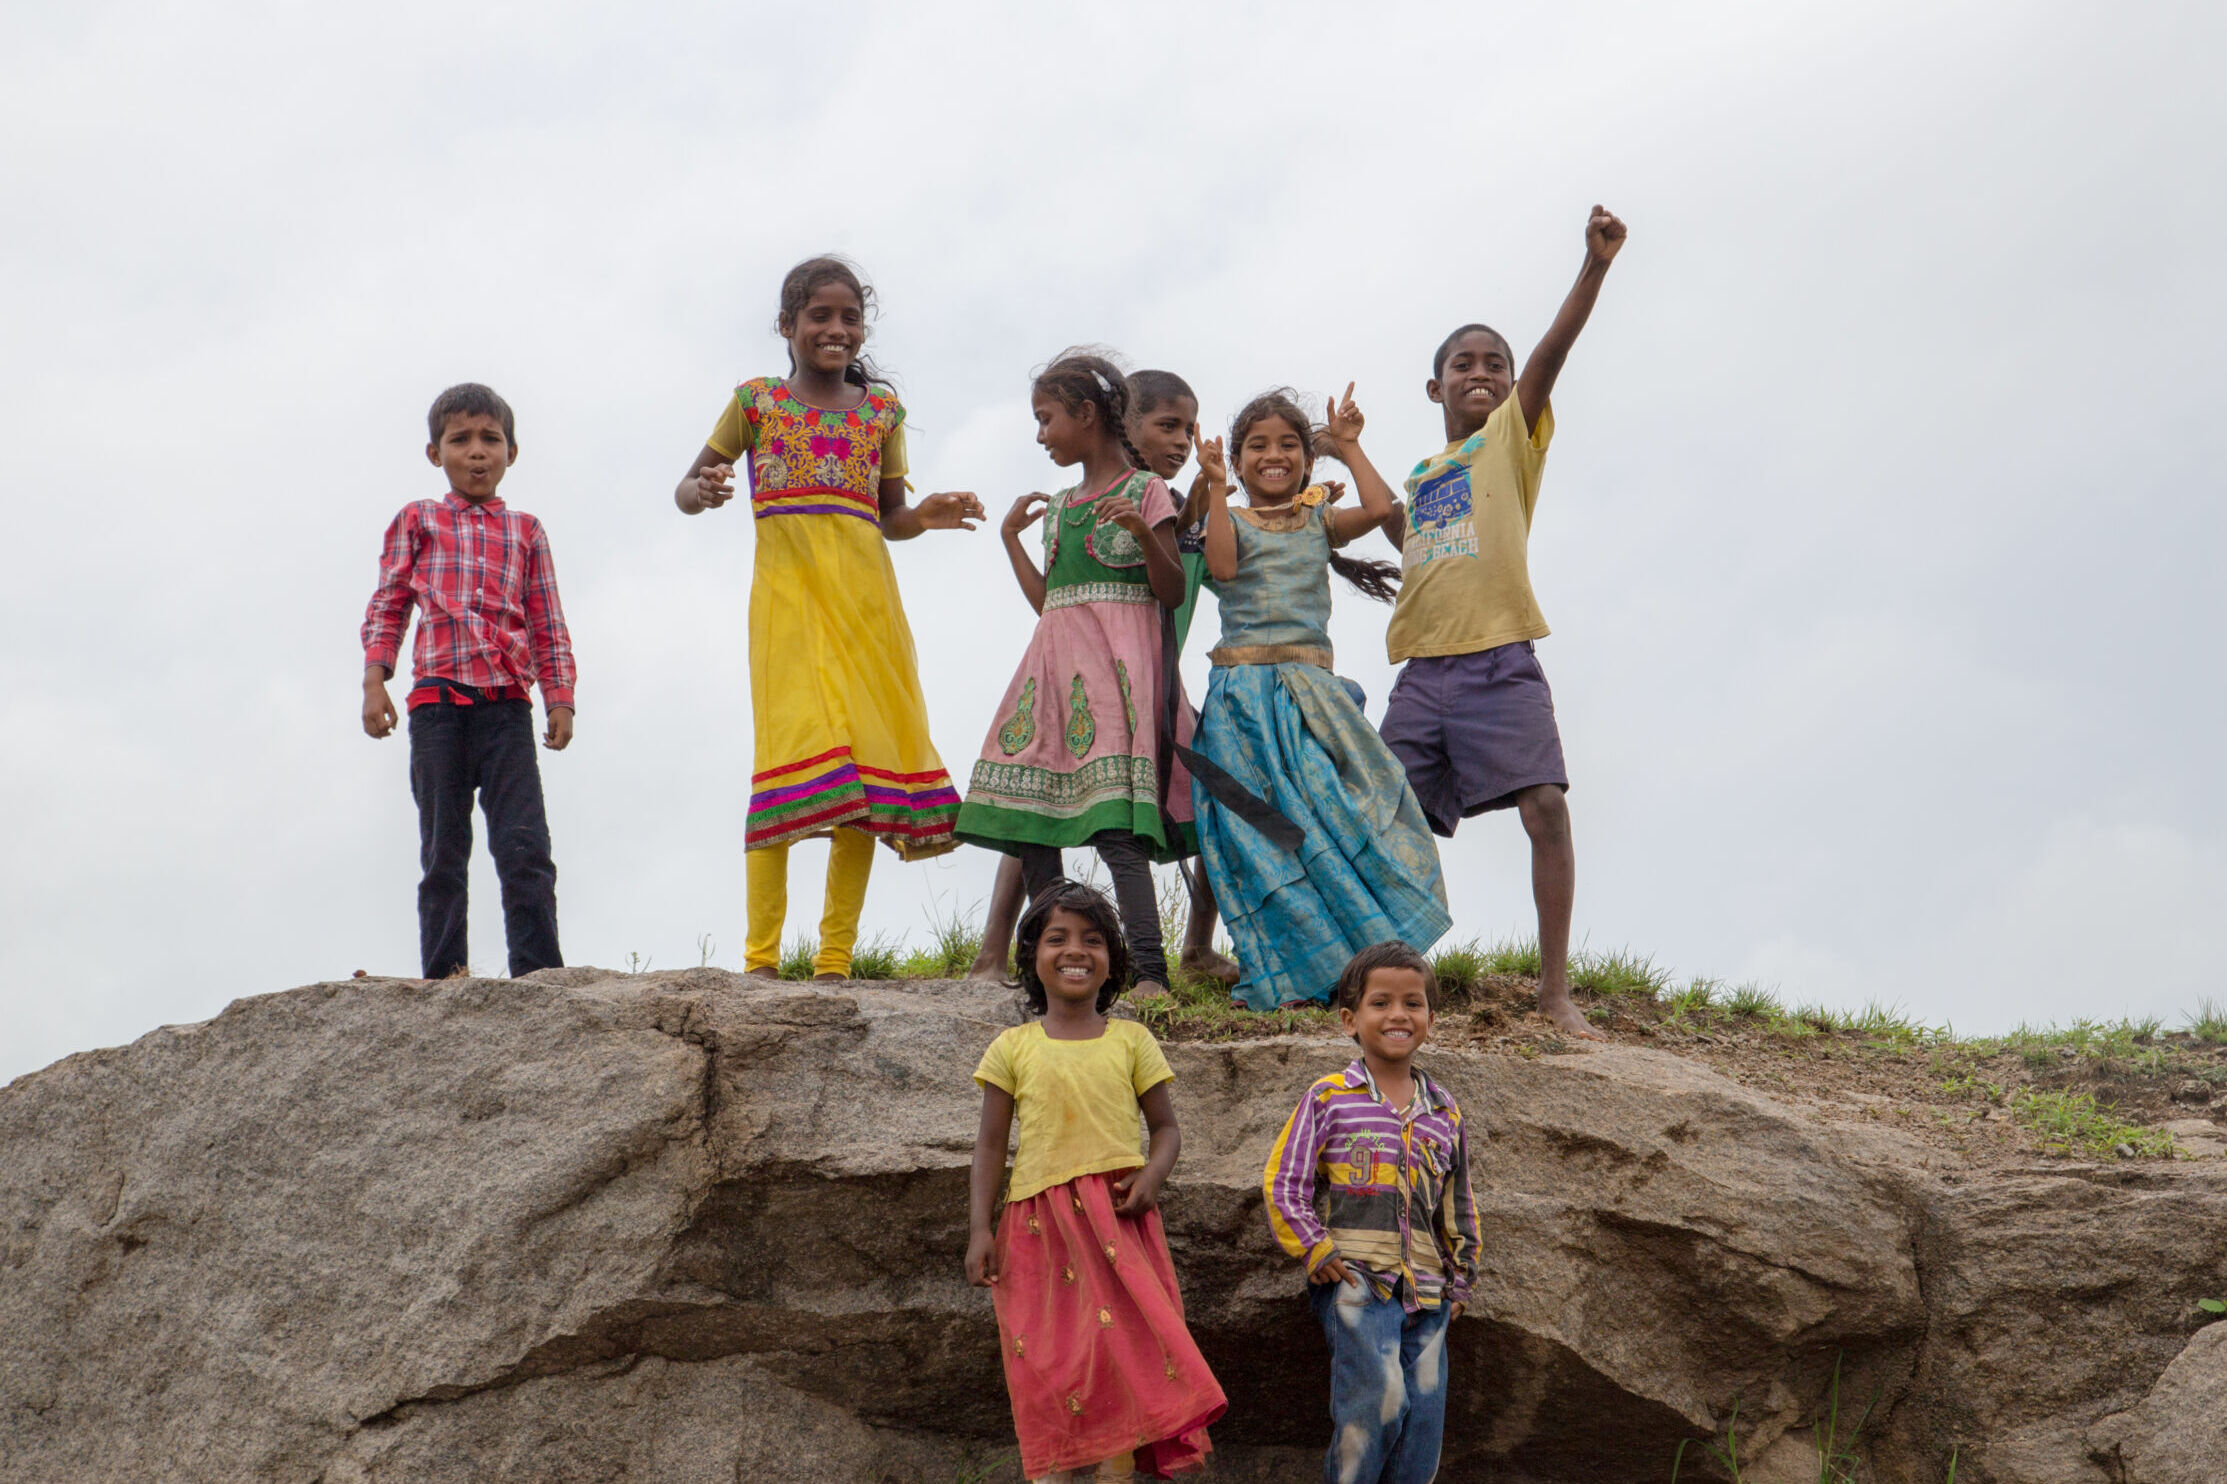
[1385, 392, 1554, 664]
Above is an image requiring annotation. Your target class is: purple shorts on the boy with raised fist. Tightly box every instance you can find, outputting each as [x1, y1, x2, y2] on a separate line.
[1376, 640, 1570, 836]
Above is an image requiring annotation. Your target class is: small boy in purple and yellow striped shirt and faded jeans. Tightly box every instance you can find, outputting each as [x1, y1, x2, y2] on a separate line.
[1263, 943, 1477, 1484]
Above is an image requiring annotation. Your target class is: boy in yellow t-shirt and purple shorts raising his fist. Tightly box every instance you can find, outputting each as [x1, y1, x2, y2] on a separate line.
[1381, 205, 1623, 1041]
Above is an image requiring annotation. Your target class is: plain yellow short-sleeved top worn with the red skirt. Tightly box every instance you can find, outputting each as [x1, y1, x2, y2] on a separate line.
[975, 1021, 1176, 1201]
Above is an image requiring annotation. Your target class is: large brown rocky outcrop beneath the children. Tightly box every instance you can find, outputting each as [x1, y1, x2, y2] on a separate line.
[0, 969, 2227, 1484]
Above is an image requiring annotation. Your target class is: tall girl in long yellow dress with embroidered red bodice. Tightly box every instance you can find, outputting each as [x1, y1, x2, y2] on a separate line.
[673, 258, 982, 978]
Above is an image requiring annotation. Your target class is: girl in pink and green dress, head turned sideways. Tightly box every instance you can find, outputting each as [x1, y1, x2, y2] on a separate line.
[958, 350, 1196, 992]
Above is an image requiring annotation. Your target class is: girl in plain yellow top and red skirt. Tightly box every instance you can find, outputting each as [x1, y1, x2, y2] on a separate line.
[967, 880, 1229, 1480]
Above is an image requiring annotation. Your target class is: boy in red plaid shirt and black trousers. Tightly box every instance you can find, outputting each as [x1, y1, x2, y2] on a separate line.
[363, 381, 572, 978]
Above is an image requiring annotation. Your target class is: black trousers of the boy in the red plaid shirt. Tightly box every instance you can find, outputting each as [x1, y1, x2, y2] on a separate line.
[410, 700, 563, 978]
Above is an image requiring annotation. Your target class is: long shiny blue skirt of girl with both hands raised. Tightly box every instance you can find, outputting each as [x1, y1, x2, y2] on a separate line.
[1191, 664, 1452, 1009]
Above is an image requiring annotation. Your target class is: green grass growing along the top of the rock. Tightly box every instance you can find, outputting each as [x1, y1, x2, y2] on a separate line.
[685, 873, 2227, 1161]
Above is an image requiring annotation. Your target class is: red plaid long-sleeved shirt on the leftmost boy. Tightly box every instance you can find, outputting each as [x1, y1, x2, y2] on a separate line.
[363, 490, 575, 706]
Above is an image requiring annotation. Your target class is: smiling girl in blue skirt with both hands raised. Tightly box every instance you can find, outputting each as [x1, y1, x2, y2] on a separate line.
[1183, 385, 1452, 1009]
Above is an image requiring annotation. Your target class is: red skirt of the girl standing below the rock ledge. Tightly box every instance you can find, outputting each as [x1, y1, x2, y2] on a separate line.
[993, 1174, 1229, 1480]
